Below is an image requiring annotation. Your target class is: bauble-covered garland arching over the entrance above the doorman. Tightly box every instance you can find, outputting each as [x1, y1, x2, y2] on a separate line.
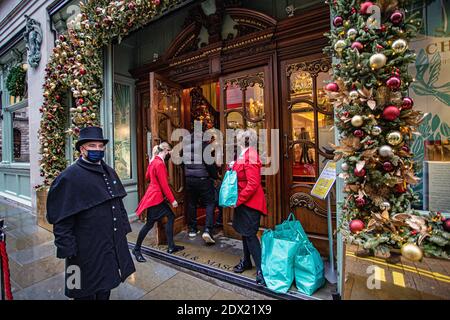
[36, 0, 170, 189]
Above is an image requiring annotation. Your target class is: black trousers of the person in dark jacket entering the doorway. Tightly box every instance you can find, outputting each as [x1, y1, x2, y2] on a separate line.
[186, 177, 216, 231]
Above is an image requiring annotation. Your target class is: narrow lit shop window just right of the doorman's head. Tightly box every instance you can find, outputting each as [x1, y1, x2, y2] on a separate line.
[113, 83, 133, 180]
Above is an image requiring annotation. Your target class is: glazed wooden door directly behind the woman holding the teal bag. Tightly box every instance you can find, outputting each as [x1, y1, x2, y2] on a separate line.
[220, 67, 277, 238]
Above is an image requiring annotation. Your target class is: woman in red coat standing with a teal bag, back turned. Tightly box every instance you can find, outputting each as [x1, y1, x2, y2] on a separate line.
[233, 129, 267, 285]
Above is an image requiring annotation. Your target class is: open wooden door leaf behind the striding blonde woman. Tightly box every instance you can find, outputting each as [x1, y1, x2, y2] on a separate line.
[148, 72, 185, 244]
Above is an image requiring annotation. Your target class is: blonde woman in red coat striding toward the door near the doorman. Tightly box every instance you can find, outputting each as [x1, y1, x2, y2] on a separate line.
[133, 142, 184, 262]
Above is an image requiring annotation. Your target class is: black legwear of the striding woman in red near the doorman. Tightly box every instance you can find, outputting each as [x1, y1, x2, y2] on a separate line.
[134, 202, 175, 250]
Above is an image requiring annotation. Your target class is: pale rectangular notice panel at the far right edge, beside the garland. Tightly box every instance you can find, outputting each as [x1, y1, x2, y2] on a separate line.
[427, 161, 450, 212]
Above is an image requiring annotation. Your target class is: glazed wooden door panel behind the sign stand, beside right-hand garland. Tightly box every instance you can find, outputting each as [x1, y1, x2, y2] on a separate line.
[281, 59, 335, 255]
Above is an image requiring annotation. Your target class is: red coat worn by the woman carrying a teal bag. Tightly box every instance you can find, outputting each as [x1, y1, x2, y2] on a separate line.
[233, 147, 267, 214]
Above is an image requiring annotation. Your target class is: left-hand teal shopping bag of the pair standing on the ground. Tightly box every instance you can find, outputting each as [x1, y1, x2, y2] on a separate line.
[261, 229, 299, 293]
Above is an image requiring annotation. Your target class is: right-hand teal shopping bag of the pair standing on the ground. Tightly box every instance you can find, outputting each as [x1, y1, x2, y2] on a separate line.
[294, 241, 325, 295]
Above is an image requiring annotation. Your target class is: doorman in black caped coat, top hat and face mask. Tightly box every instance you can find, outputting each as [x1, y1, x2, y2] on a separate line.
[47, 127, 136, 300]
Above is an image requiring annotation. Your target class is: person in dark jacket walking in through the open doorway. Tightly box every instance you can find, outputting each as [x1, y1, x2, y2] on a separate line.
[183, 126, 219, 244]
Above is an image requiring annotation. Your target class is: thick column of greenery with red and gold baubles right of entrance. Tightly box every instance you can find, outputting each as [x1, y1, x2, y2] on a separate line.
[325, 0, 450, 261]
